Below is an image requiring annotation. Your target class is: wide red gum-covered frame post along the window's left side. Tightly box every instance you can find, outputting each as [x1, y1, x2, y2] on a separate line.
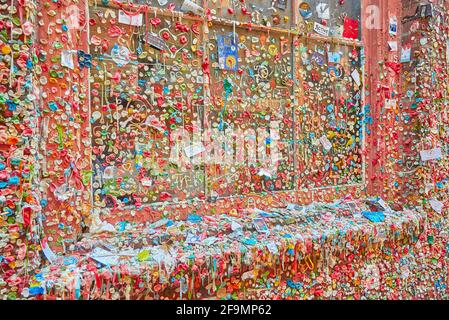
[36, 1, 91, 249]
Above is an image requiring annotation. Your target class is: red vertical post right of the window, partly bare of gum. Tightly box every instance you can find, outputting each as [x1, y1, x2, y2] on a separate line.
[362, 1, 402, 199]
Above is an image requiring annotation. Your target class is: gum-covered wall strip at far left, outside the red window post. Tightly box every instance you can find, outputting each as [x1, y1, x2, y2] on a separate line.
[0, 1, 42, 297]
